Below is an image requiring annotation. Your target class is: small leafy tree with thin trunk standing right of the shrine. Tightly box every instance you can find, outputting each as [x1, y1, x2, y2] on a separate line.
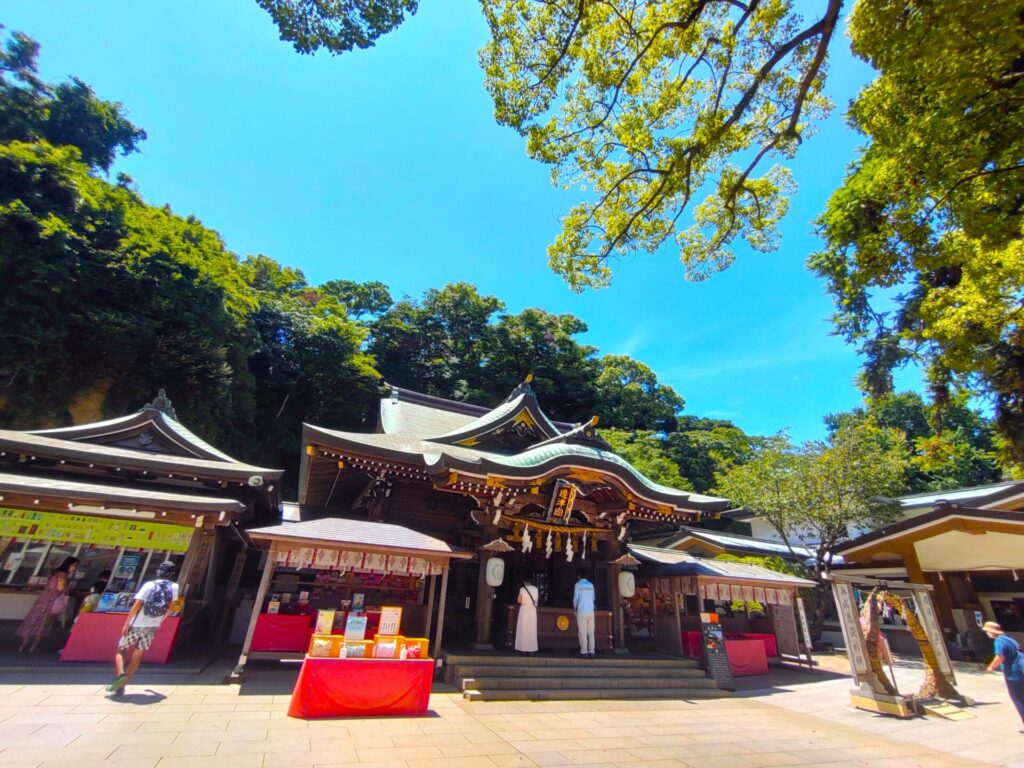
[718, 421, 907, 635]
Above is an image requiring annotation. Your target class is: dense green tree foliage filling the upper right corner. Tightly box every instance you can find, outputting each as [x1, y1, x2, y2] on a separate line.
[810, 0, 1024, 464]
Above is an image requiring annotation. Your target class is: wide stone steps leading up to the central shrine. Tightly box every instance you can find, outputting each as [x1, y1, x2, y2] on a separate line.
[444, 653, 729, 701]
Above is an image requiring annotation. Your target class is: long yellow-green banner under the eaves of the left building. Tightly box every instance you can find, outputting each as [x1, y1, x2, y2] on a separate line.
[0, 507, 193, 552]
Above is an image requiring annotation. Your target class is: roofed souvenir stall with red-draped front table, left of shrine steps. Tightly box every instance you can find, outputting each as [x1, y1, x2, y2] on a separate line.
[236, 518, 473, 719]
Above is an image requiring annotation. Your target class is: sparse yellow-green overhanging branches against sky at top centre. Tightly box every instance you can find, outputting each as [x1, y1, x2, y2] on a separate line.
[480, 0, 842, 291]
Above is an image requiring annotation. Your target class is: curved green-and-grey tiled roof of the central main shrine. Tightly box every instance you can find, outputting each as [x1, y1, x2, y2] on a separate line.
[299, 379, 730, 521]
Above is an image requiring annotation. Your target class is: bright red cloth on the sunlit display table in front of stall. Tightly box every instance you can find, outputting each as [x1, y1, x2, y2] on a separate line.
[288, 656, 434, 720]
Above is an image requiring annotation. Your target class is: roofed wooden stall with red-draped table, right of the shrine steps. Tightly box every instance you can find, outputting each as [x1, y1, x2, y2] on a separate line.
[626, 545, 815, 676]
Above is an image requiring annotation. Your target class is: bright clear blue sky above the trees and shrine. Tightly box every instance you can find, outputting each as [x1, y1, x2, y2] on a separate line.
[0, 0, 913, 439]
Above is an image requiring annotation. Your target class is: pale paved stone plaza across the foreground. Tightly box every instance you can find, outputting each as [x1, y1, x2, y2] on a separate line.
[0, 655, 1024, 768]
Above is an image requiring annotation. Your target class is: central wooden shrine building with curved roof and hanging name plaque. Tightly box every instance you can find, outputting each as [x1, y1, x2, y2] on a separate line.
[299, 380, 729, 648]
